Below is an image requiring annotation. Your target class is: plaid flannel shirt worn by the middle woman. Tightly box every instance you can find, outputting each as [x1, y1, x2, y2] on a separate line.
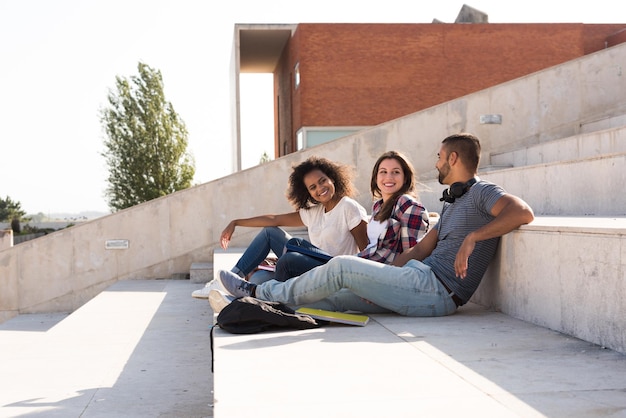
[357, 194, 429, 264]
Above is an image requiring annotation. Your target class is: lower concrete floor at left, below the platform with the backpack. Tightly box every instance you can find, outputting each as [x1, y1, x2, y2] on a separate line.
[0, 280, 213, 418]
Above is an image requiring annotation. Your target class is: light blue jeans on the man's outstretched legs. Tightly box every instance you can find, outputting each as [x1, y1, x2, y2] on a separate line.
[256, 256, 456, 317]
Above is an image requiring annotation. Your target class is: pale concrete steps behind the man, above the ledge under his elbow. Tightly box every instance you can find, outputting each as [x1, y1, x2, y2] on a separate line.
[420, 127, 626, 217]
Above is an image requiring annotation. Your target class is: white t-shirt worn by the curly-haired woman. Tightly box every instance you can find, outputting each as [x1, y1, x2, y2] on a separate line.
[299, 196, 367, 255]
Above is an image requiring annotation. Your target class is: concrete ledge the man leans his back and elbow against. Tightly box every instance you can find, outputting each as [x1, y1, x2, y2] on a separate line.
[472, 216, 626, 353]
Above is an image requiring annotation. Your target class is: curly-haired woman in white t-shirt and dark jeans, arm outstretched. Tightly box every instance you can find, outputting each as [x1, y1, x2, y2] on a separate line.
[192, 157, 368, 298]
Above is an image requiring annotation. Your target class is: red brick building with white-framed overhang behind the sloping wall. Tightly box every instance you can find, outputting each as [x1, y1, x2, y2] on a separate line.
[233, 7, 626, 169]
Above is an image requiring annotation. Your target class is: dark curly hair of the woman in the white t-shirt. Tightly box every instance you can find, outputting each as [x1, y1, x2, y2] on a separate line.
[287, 156, 356, 210]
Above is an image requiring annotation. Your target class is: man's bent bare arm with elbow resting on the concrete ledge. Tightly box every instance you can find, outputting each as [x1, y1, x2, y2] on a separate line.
[454, 194, 535, 279]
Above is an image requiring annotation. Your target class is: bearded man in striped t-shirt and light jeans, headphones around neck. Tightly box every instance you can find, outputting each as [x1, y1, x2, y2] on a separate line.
[209, 133, 534, 316]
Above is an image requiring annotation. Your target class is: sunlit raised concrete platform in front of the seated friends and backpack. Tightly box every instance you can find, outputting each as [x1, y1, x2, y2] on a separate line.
[215, 304, 626, 418]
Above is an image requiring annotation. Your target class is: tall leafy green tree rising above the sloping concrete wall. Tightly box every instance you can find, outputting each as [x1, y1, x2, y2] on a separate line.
[101, 62, 195, 211]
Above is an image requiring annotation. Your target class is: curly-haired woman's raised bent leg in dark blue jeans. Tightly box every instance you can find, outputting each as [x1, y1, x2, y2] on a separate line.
[231, 226, 291, 277]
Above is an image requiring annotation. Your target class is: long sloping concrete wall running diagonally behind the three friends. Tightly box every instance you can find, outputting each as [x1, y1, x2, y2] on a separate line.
[0, 44, 626, 321]
